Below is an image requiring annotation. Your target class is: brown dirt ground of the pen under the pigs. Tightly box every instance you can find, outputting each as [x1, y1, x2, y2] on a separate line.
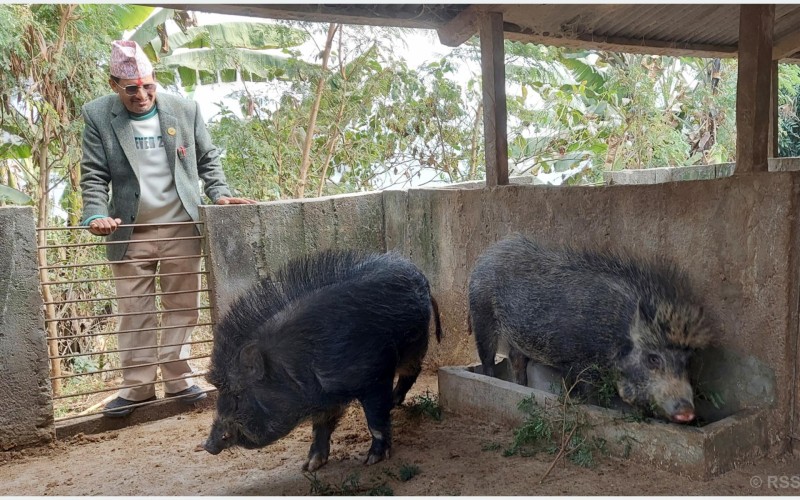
[0, 374, 800, 496]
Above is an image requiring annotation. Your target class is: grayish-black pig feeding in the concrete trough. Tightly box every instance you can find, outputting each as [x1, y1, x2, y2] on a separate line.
[469, 235, 712, 423]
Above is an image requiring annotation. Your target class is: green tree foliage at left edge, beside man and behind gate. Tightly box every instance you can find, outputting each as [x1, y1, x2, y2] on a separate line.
[0, 4, 134, 394]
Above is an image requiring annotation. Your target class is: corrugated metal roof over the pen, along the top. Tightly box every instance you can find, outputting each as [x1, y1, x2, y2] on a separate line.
[169, 4, 800, 59]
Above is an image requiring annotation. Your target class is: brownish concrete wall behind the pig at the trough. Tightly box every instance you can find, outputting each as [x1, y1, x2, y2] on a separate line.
[384, 173, 800, 456]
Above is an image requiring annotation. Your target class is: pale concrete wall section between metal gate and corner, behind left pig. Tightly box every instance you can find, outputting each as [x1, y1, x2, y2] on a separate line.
[200, 193, 385, 317]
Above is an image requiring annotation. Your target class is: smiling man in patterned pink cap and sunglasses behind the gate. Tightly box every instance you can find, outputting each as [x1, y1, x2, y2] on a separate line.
[81, 40, 255, 417]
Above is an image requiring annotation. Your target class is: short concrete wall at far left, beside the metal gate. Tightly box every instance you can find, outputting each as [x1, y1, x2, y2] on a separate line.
[0, 207, 55, 451]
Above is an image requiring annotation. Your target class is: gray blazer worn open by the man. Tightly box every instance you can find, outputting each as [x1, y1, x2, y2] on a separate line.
[81, 93, 231, 260]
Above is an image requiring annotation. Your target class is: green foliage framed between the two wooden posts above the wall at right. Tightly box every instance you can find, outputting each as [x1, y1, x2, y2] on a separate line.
[506, 42, 736, 184]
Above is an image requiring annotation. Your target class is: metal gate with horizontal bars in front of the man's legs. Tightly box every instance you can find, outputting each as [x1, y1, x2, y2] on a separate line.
[37, 222, 213, 423]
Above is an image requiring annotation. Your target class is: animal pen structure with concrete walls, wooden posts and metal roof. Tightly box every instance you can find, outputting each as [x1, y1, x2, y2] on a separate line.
[0, 4, 800, 476]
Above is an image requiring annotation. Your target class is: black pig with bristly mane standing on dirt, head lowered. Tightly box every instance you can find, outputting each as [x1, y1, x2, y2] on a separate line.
[204, 251, 441, 472]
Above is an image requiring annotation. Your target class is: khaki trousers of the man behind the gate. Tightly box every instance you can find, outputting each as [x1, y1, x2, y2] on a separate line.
[111, 224, 202, 401]
